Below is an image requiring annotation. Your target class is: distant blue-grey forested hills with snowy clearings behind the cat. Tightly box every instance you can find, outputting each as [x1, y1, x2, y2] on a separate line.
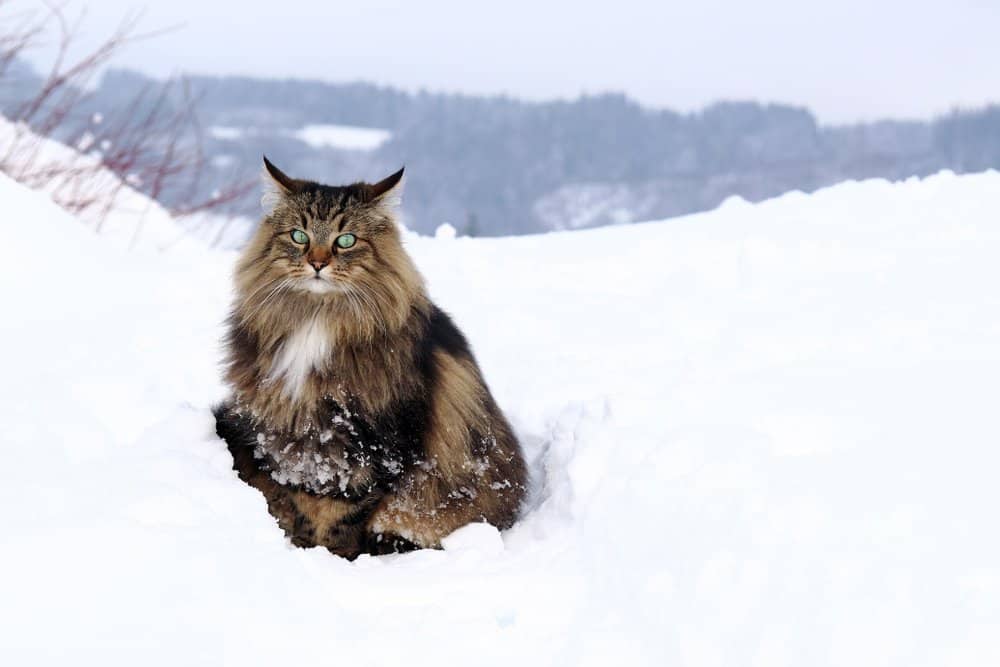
[8, 65, 1000, 236]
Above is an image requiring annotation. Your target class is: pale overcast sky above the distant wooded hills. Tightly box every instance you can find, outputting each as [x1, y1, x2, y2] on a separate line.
[15, 0, 1000, 122]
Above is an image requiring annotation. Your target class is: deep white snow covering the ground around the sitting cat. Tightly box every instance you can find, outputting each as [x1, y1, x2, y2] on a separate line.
[0, 173, 1000, 667]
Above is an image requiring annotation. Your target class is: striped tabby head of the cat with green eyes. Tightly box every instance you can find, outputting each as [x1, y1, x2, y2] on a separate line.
[236, 157, 422, 332]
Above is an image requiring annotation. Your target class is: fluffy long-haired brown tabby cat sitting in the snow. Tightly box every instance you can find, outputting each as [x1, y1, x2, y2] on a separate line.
[215, 158, 526, 558]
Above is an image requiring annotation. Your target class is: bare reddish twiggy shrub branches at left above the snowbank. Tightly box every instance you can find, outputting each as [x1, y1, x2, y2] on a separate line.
[0, 0, 250, 237]
